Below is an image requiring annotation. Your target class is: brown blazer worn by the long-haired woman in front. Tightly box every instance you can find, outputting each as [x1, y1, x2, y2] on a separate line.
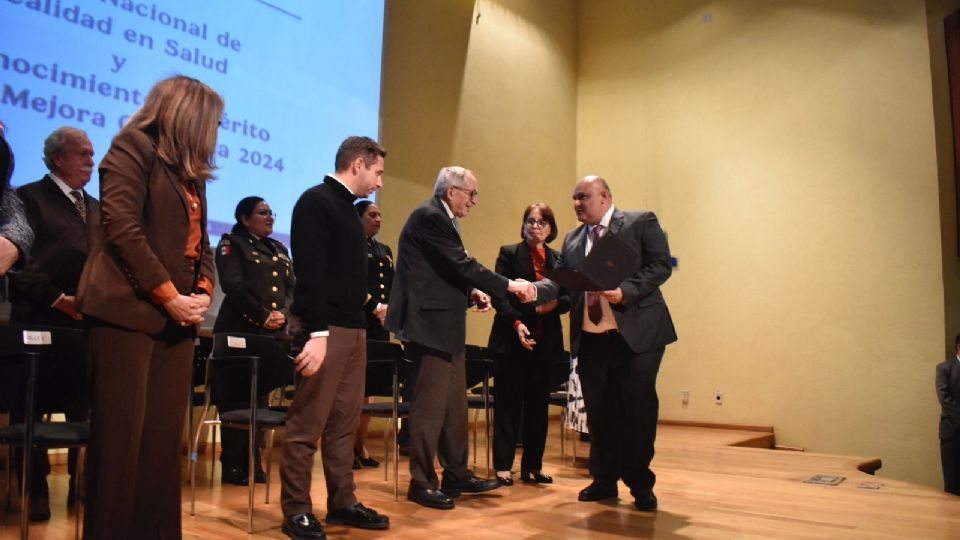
[77, 129, 214, 334]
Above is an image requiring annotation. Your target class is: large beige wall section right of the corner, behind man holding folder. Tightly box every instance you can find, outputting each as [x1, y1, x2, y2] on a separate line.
[577, 0, 944, 484]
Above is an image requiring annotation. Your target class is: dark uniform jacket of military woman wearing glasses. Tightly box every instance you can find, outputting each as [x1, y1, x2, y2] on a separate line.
[213, 227, 295, 334]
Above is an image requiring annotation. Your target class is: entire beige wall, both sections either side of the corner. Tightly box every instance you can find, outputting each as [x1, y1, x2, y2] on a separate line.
[382, 0, 960, 485]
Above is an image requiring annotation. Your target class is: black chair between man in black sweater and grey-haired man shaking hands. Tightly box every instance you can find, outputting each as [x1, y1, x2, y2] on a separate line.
[361, 339, 410, 500]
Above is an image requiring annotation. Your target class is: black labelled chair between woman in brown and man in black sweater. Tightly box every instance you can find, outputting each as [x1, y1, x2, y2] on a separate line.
[189, 333, 293, 533]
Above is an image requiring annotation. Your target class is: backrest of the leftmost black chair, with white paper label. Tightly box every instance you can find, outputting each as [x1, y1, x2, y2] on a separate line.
[0, 325, 86, 414]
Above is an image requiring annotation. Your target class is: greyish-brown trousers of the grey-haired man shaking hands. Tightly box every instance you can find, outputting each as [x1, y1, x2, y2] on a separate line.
[407, 343, 470, 489]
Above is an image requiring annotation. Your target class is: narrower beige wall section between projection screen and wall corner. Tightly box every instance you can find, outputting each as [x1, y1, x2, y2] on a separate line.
[381, 0, 576, 345]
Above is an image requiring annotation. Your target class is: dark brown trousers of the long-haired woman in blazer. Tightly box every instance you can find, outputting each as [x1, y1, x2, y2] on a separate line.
[83, 324, 194, 540]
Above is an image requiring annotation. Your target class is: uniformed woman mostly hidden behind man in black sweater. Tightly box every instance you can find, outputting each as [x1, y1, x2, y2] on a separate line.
[353, 200, 393, 469]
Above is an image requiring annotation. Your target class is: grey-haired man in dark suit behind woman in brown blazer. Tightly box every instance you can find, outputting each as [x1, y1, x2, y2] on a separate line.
[10, 126, 100, 521]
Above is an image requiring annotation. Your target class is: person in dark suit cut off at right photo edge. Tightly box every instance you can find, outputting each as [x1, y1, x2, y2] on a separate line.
[936, 334, 960, 495]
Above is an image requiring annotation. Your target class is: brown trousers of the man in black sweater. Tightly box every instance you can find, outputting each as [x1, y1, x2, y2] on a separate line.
[280, 326, 367, 516]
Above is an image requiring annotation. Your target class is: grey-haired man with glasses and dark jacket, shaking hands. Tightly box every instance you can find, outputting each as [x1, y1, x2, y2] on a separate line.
[386, 167, 534, 509]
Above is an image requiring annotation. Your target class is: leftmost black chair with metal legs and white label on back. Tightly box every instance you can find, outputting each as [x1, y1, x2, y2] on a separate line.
[0, 326, 90, 539]
